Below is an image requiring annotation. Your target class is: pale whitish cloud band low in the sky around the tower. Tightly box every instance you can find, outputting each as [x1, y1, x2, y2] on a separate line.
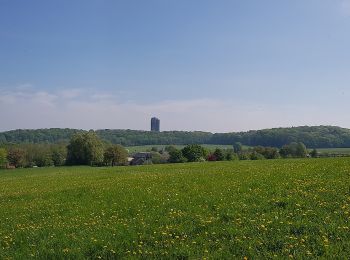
[0, 89, 350, 132]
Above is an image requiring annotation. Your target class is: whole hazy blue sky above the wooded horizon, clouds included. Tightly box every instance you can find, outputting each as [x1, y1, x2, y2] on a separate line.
[0, 0, 350, 132]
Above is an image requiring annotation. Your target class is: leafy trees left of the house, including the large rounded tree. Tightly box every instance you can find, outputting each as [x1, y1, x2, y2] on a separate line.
[0, 131, 128, 168]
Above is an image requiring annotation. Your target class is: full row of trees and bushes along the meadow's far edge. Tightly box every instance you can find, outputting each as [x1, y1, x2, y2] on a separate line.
[0, 131, 317, 168]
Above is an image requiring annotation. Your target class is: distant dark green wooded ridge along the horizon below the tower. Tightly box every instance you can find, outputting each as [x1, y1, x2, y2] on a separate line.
[0, 126, 350, 148]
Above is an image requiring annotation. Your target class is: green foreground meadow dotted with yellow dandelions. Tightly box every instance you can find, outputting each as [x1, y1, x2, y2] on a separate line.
[0, 158, 350, 259]
